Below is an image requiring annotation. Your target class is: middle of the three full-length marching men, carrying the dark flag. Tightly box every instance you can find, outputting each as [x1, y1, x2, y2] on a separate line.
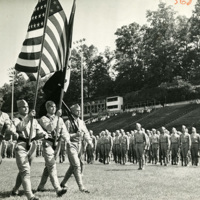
[37, 101, 70, 197]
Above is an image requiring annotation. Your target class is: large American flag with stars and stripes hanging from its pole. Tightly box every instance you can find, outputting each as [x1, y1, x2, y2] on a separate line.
[15, 0, 68, 79]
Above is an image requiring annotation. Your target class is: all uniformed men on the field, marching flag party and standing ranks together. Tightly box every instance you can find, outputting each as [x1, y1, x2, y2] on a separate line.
[0, 93, 200, 200]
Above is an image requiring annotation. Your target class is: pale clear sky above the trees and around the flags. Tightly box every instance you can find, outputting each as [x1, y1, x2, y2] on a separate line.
[0, 0, 197, 87]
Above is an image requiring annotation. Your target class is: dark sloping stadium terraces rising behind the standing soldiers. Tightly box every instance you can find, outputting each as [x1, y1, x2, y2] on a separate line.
[87, 104, 200, 134]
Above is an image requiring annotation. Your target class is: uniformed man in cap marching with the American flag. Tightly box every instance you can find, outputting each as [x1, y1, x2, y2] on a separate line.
[11, 100, 47, 200]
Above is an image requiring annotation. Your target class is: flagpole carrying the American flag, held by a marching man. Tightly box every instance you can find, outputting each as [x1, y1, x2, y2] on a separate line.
[27, 0, 51, 148]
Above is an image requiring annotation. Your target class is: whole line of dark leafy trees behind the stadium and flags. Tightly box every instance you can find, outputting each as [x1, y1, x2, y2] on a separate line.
[1, 0, 200, 112]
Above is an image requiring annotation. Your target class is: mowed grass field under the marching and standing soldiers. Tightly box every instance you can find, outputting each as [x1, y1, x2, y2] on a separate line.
[0, 157, 200, 200]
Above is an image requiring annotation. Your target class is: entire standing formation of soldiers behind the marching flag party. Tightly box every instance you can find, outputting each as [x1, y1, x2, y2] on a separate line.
[2, 116, 200, 173]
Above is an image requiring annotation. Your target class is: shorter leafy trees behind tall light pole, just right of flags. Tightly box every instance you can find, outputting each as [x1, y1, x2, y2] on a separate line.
[66, 45, 114, 102]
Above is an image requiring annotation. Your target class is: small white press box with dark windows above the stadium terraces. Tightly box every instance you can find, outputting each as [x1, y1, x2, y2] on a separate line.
[106, 96, 123, 112]
